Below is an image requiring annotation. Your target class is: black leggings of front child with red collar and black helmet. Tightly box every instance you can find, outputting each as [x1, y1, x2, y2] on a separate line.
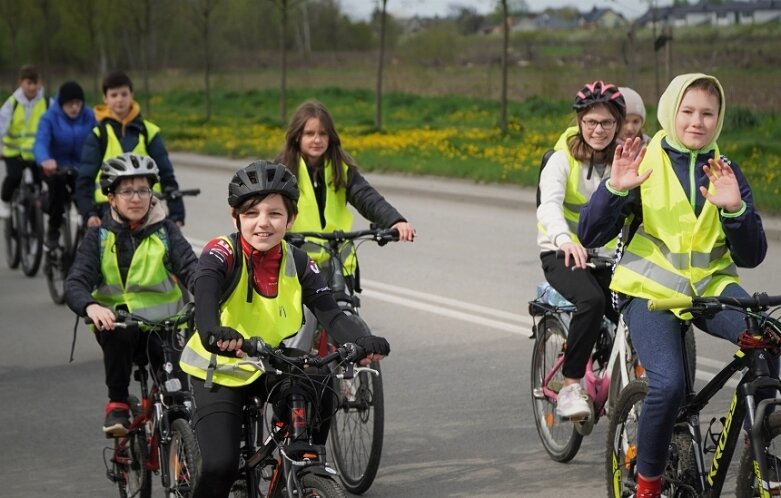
[191, 374, 334, 498]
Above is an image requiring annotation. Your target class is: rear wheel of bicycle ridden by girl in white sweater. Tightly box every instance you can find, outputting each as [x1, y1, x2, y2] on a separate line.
[530, 316, 583, 463]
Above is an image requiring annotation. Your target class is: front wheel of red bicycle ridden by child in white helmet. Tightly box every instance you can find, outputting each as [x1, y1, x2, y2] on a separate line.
[167, 418, 201, 498]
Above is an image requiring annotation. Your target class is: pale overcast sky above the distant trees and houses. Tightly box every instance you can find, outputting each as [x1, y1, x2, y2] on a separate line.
[341, 0, 672, 20]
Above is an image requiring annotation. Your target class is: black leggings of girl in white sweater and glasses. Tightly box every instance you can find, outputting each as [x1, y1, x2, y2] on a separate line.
[540, 252, 618, 379]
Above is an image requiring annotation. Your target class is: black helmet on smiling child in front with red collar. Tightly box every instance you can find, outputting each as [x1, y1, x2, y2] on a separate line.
[228, 161, 299, 207]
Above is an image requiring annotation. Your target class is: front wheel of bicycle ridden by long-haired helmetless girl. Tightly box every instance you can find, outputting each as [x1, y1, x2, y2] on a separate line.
[328, 315, 385, 494]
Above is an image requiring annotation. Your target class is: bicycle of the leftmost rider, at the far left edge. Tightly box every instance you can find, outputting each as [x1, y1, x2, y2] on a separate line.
[3, 167, 43, 277]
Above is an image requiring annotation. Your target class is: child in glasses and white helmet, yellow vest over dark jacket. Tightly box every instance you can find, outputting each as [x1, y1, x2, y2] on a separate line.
[65, 153, 197, 437]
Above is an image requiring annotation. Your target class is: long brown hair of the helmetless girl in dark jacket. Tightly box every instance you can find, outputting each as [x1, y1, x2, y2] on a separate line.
[276, 99, 358, 190]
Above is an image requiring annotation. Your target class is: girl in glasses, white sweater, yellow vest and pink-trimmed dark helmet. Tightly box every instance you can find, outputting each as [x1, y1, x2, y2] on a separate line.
[537, 81, 626, 419]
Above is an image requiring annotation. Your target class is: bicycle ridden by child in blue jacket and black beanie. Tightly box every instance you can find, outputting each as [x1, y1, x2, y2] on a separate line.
[43, 168, 85, 304]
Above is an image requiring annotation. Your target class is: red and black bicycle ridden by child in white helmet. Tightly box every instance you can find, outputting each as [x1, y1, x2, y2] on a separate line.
[85, 304, 200, 498]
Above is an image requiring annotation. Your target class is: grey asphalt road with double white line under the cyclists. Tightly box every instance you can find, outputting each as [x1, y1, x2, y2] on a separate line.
[0, 160, 781, 498]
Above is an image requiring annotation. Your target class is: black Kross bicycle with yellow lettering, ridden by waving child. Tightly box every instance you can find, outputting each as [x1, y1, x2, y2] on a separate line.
[605, 293, 781, 498]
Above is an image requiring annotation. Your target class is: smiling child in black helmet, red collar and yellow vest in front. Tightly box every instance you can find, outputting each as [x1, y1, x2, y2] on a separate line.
[181, 161, 390, 498]
